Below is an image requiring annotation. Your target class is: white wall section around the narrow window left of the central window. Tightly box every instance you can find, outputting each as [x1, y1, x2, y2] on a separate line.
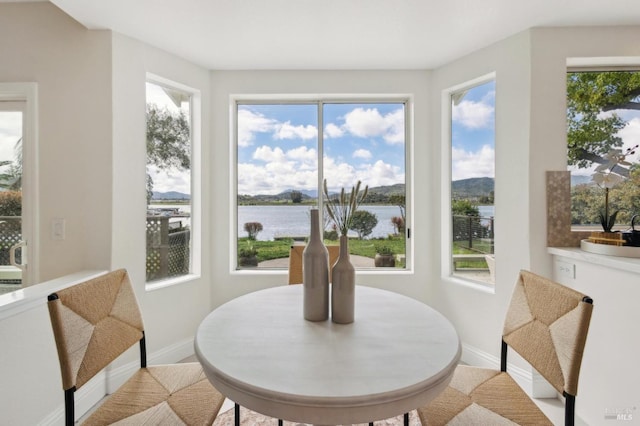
[110, 34, 215, 360]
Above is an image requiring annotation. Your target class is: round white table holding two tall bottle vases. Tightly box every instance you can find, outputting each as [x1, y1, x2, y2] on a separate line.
[195, 285, 460, 424]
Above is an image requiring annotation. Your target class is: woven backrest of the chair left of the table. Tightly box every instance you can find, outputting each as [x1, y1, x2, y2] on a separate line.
[47, 269, 144, 391]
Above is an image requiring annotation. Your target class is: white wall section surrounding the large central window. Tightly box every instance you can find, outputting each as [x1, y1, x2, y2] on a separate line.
[208, 71, 432, 307]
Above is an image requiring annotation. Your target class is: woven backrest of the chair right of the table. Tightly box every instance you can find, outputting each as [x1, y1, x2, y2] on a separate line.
[502, 271, 593, 396]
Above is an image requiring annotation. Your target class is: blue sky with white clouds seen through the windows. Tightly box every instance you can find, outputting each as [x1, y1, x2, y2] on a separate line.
[147, 77, 640, 195]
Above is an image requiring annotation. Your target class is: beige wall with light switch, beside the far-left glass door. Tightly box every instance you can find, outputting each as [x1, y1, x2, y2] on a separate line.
[0, 3, 111, 281]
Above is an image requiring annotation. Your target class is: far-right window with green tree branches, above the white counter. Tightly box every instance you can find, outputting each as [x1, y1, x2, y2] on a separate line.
[567, 71, 640, 235]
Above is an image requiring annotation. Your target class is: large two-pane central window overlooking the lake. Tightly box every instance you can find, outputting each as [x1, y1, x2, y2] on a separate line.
[235, 100, 408, 270]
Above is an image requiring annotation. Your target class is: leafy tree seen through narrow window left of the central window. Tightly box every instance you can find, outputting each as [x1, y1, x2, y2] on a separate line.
[147, 104, 191, 202]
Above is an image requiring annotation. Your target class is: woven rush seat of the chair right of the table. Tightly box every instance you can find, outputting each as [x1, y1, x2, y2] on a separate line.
[418, 365, 553, 426]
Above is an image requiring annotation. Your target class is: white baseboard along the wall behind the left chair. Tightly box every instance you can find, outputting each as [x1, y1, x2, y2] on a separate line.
[38, 338, 193, 426]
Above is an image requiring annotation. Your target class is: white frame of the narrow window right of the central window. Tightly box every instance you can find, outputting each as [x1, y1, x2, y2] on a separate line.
[440, 75, 498, 294]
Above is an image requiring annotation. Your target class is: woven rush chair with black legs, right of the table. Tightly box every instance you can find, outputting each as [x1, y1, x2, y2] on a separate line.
[418, 271, 593, 426]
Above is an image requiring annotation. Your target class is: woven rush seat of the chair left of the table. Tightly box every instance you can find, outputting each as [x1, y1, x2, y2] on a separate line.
[83, 363, 224, 426]
